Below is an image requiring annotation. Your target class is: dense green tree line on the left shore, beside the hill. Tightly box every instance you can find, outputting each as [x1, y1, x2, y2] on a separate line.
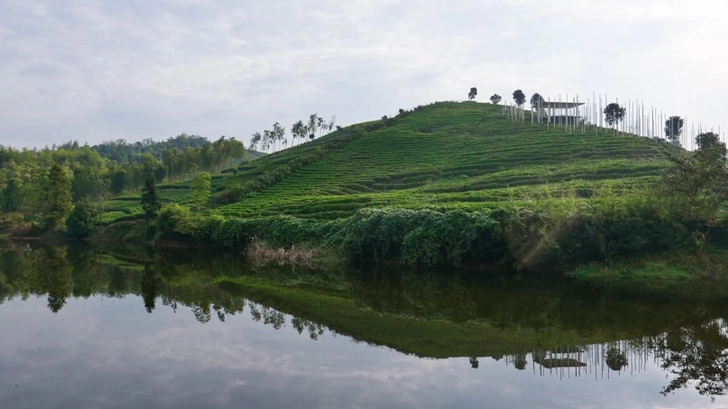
[0, 134, 246, 230]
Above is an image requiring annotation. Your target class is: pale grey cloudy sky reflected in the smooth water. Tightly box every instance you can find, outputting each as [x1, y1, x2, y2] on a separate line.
[0, 296, 726, 409]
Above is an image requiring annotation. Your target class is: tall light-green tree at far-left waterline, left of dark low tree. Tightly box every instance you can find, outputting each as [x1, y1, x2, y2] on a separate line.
[42, 163, 73, 230]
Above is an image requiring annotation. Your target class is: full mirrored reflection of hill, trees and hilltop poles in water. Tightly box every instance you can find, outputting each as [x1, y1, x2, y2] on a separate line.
[0, 241, 728, 407]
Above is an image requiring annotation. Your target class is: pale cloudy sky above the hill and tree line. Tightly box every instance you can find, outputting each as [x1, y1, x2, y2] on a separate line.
[0, 0, 728, 148]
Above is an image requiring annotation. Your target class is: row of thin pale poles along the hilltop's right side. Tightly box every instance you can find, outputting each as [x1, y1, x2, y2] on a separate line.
[503, 93, 726, 150]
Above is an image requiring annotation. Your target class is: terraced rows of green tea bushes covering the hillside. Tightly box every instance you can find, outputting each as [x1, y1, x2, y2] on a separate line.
[99, 102, 667, 222]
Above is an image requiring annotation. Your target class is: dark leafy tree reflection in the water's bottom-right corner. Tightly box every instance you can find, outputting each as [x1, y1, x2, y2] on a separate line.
[652, 320, 728, 397]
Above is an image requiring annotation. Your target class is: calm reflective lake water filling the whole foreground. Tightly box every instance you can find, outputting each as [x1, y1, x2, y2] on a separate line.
[0, 246, 728, 409]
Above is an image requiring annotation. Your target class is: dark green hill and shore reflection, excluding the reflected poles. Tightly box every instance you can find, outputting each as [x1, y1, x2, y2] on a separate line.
[0, 242, 723, 357]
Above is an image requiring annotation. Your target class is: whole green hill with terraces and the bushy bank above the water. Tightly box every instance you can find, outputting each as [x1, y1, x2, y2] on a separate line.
[6, 102, 728, 276]
